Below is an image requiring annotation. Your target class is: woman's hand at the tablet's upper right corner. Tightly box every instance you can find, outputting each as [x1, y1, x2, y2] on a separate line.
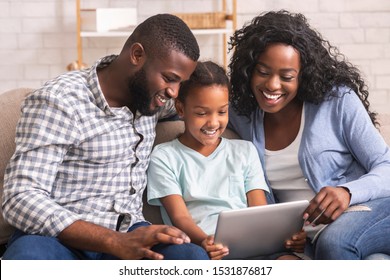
[303, 186, 351, 225]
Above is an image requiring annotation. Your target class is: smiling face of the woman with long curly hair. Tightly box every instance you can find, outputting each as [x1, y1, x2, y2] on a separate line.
[251, 44, 300, 113]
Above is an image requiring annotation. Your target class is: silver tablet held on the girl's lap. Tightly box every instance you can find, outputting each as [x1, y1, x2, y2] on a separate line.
[214, 200, 309, 259]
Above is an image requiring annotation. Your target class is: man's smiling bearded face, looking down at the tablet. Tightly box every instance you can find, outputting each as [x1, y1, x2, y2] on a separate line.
[128, 51, 196, 116]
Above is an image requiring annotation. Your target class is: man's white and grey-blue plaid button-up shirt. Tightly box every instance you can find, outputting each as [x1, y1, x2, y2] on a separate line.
[3, 56, 174, 236]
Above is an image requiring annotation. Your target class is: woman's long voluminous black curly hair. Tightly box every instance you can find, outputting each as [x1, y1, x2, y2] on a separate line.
[229, 10, 378, 125]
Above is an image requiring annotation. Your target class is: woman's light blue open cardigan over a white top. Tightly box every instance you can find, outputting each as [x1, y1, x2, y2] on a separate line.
[229, 87, 390, 205]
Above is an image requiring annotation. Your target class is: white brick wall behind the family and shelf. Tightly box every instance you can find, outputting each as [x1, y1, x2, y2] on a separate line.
[0, 0, 390, 112]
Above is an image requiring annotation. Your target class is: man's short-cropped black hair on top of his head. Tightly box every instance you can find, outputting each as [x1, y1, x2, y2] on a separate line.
[125, 14, 199, 61]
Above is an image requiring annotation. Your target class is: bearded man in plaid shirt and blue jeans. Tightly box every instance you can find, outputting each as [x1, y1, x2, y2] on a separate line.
[2, 14, 207, 259]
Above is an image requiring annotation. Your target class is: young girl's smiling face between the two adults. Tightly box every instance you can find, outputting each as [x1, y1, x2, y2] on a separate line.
[176, 85, 229, 156]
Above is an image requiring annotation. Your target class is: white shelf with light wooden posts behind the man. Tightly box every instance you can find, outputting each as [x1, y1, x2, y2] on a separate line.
[73, 0, 237, 70]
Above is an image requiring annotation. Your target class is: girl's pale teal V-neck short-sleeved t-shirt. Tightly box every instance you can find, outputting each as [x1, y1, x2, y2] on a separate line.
[147, 138, 269, 235]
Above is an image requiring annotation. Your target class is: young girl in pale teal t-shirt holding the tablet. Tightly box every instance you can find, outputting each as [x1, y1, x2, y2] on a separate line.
[147, 61, 306, 259]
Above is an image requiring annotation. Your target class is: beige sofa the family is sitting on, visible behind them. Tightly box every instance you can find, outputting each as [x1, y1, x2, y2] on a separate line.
[0, 88, 390, 256]
